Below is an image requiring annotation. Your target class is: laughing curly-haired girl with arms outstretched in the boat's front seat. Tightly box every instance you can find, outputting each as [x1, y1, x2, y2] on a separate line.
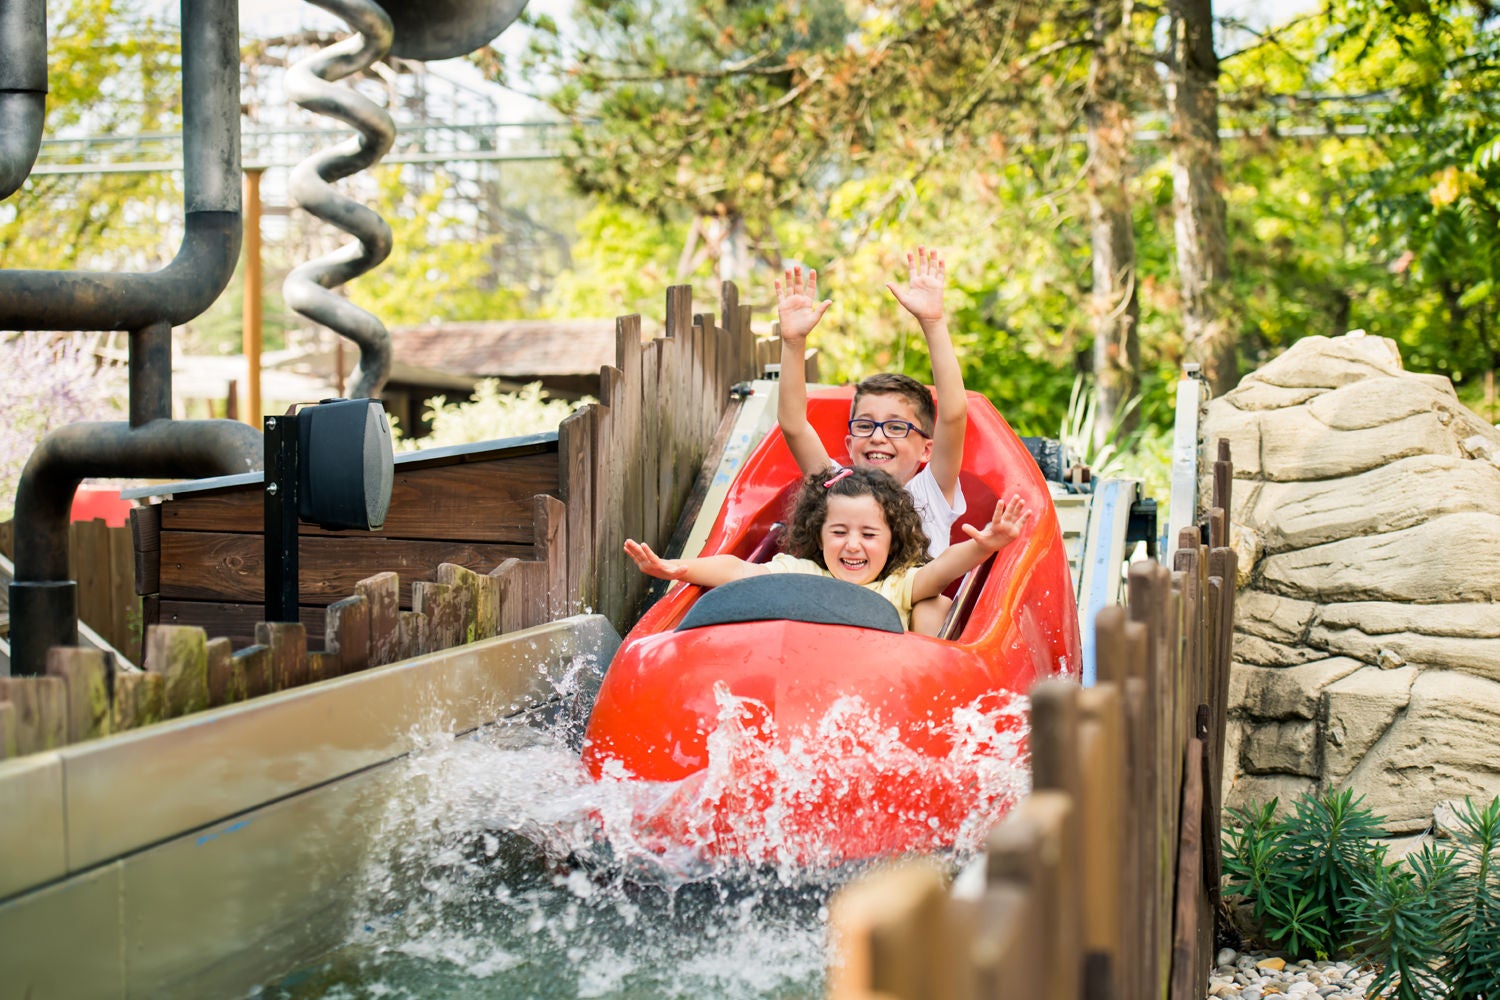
[626, 469, 1028, 638]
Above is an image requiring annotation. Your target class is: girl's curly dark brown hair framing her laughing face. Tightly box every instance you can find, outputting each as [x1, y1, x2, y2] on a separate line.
[786, 469, 927, 580]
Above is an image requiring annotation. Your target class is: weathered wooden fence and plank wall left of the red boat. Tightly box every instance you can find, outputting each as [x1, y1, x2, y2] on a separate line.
[0, 282, 779, 757]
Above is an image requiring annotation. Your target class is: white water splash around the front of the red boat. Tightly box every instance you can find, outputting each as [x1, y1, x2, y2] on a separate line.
[261, 663, 1028, 999]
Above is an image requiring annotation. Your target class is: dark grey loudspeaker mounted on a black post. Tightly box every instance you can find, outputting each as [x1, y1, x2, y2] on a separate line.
[297, 399, 395, 531]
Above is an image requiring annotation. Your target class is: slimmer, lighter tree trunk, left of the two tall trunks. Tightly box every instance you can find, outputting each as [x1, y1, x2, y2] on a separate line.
[1085, 0, 1140, 448]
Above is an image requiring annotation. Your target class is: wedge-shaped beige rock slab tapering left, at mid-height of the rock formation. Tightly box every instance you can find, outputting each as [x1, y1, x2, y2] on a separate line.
[1262, 513, 1500, 604]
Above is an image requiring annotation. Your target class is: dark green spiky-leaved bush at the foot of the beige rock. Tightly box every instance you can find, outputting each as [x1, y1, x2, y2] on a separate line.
[1224, 792, 1500, 1000]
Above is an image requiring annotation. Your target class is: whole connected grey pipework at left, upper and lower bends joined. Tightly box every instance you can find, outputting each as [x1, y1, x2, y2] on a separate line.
[0, 0, 250, 675]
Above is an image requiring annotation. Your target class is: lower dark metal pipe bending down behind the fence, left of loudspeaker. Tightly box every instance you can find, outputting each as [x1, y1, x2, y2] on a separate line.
[11, 420, 261, 676]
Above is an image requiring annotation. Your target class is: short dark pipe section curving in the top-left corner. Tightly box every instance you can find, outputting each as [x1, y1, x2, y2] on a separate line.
[0, 0, 47, 201]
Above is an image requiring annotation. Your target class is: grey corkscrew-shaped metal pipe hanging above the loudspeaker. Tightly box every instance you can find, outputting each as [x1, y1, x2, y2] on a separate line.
[282, 0, 396, 399]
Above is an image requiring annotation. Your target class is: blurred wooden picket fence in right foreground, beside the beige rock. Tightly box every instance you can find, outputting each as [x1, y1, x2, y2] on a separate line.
[830, 442, 1235, 1000]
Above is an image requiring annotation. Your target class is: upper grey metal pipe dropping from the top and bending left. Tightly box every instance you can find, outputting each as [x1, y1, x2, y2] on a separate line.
[0, 0, 242, 330]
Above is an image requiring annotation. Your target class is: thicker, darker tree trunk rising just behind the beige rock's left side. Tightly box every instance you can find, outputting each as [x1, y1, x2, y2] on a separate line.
[1167, 0, 1239, 396]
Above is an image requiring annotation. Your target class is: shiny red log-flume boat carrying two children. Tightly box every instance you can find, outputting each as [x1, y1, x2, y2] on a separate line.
[584, 388, 1080, 864]
